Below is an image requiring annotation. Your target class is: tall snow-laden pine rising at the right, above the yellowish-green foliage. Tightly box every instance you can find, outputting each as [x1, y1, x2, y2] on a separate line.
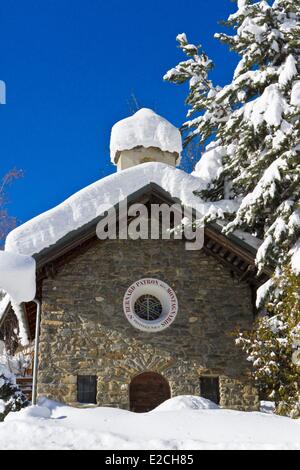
[167, 0, 300, 294]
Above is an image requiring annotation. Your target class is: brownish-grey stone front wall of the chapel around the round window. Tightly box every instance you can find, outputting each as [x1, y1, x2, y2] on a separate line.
[38, 240, 258, 410]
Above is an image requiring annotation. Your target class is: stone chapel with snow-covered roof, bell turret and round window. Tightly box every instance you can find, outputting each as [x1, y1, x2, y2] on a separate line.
[0, 109, 269, 412]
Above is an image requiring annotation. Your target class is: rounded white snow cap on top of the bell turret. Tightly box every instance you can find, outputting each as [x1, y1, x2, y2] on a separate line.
[110, 108, 182, 163]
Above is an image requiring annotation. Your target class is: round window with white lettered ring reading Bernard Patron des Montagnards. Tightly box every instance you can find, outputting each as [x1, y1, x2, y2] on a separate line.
[123, 278, 178, 333]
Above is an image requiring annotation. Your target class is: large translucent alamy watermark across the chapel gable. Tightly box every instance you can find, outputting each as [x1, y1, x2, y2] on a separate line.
[96, 199, 204, 251]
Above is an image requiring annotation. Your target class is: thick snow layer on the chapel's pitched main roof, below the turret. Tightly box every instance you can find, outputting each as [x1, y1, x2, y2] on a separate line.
[5, 163, 237, 255]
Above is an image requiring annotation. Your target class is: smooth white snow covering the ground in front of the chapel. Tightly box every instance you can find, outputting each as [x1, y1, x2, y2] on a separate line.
[0, 397, 300, 450]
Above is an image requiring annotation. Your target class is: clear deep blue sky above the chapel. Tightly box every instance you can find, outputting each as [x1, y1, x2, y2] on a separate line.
[0, 0, 237, 228]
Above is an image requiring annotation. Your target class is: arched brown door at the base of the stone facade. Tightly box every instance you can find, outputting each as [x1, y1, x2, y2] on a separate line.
[129, 372, 171, 413]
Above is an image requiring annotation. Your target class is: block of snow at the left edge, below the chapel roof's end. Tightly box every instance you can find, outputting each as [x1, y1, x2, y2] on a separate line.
[0, 251, 36, 305]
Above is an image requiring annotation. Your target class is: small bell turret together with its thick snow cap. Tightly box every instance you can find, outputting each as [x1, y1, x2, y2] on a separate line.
[110, 108, 182, 171]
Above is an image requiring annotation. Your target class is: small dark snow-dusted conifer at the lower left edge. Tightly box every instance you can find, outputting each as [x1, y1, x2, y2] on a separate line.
[0, 364, 29, 422]
